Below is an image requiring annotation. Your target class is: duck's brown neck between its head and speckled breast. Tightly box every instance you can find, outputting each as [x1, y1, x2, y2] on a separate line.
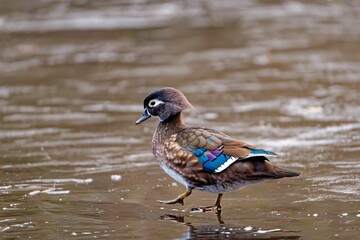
[153, 112, 185, 143]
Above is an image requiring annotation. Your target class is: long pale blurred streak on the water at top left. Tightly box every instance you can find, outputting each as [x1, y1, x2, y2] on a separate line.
[1, 3, 181, 32]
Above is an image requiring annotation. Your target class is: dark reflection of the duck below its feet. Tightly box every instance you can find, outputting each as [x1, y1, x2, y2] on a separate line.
[161, 215, 301, 240]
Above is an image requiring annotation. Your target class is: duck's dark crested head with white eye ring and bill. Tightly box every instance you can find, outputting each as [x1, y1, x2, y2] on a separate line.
[135, 87, 192, 125]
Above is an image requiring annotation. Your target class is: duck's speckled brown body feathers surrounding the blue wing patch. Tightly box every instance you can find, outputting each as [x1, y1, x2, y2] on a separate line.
[158, 119, 296, 190]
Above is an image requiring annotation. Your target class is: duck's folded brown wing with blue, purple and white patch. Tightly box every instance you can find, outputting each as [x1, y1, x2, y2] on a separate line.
[172, 128, 277, 173]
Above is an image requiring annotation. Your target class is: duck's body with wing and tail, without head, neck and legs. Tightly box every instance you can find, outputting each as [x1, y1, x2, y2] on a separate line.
[153, 126, 299, 192]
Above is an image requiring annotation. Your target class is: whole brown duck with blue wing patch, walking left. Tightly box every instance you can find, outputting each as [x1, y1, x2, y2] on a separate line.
[136, 87, 300, 211]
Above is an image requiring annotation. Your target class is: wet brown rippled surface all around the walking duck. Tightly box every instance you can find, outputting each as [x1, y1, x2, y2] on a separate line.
[0, 0, 360, 239]
